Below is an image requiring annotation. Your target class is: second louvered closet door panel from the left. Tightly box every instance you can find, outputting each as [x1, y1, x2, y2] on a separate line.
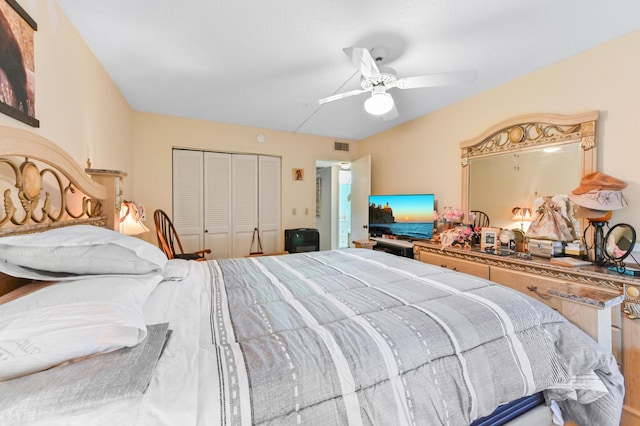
[204, 152, 233, 259]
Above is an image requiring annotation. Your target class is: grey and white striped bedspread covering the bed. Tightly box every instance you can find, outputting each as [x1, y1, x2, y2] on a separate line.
[207, 249, 624, 426]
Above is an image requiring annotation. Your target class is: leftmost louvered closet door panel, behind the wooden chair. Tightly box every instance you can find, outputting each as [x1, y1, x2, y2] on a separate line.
[167, 149, 204, 252]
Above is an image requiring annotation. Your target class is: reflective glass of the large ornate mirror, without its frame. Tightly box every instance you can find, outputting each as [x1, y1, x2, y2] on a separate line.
[468, 142, 582, 231]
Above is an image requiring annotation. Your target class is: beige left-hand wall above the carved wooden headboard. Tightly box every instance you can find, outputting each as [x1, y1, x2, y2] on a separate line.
[0, 0, 133, 171]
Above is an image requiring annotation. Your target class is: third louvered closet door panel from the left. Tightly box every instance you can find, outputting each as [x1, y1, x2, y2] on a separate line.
[231, 154, 258, 257]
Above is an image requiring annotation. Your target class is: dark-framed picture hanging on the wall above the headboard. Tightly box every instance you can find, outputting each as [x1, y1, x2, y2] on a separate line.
[0, 0, 40, 127]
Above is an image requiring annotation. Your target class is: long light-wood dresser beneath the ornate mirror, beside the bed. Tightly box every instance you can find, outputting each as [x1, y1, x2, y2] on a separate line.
[413, 241, 640, 425]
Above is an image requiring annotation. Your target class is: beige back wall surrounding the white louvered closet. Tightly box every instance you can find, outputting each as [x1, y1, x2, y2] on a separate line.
[128, 112, 358, 245]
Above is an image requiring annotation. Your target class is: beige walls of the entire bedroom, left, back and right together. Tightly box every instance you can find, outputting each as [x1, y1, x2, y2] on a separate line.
[0, 0, 640, 243]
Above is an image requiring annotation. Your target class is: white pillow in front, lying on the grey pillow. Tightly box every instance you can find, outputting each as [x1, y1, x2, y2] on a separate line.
[0, 275, 162, 381]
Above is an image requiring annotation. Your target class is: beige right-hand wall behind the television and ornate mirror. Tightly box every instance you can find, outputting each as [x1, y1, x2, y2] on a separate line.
[359, 31, 640, 229]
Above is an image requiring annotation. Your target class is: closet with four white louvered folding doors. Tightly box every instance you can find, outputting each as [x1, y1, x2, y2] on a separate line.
[173, 149, 282, 259]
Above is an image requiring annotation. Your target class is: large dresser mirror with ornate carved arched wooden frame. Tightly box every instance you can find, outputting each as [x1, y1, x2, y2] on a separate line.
[460, 111, 598, 231]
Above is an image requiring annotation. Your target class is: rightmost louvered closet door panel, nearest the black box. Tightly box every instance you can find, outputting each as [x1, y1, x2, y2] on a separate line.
[258, 156, 282, 253]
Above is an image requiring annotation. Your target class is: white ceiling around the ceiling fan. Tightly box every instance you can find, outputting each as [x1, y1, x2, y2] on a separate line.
[57, 0, 640, 140]
